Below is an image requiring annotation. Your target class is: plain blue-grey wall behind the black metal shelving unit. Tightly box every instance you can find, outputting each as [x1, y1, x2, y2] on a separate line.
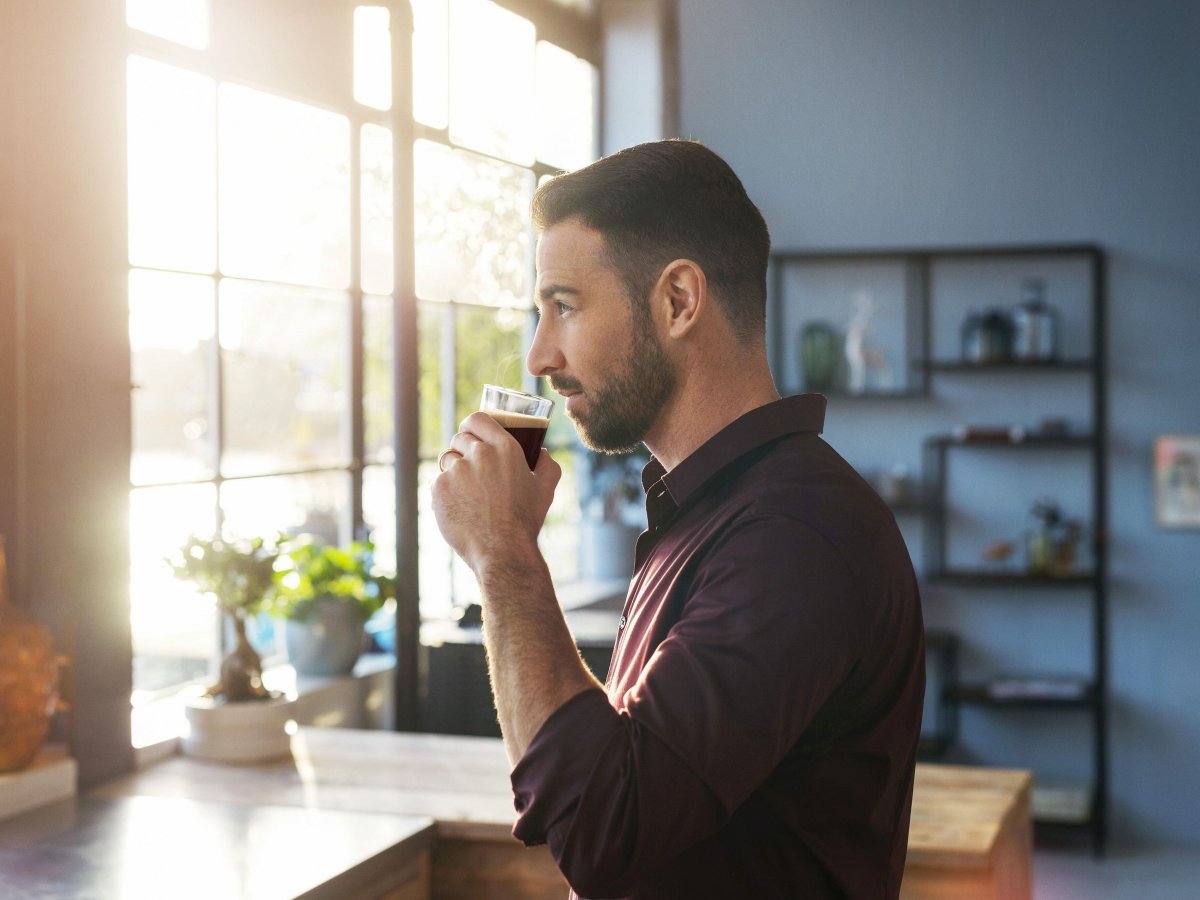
[679, 0, 1200, 844]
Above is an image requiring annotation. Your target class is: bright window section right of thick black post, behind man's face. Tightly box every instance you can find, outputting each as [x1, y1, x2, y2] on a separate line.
[413, 0, 596, 617]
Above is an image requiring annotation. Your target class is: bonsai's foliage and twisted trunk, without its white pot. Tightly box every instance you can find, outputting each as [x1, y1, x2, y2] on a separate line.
[167, 536, 280, 703]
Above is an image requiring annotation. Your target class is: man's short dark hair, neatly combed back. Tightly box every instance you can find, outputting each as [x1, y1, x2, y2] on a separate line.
[533, 139, 770, 341]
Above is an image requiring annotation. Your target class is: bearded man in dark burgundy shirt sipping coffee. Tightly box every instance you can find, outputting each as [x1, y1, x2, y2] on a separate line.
[433, 140, 924, 900]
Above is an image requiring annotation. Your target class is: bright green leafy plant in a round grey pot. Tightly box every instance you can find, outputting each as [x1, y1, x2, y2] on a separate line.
[270, 540, 396, 676]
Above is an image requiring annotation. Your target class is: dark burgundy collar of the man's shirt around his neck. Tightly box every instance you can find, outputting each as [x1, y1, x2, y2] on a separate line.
[642, 394, 826, 508]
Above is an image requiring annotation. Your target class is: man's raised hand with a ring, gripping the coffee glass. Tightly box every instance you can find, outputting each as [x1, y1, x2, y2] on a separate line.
[433, 413, 563, 575]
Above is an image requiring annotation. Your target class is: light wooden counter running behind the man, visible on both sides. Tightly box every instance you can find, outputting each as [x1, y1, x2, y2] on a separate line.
[84, 728, 1032, 900]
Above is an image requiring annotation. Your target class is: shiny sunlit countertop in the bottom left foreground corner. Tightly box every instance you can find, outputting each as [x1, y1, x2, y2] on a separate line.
[0, 791, 433, 900]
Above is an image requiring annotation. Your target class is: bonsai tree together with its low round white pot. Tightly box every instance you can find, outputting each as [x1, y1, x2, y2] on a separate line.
[167, 536, 293, 762]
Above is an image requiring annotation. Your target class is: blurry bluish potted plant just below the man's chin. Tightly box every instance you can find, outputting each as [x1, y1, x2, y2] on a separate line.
[580, 449, 649, 581]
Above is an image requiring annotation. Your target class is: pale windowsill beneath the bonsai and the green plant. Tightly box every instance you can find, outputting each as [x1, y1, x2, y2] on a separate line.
[132, 653, 396, 768]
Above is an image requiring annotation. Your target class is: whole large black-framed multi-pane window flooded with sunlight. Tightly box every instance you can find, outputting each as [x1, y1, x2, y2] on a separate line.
[126, 0, 598, 720]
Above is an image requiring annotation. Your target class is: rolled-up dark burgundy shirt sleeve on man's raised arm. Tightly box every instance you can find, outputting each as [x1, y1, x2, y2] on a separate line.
[512, 518, 854, 896]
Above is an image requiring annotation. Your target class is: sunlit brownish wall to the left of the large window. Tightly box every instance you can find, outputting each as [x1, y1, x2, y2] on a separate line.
[0, 0, 133, 787]
